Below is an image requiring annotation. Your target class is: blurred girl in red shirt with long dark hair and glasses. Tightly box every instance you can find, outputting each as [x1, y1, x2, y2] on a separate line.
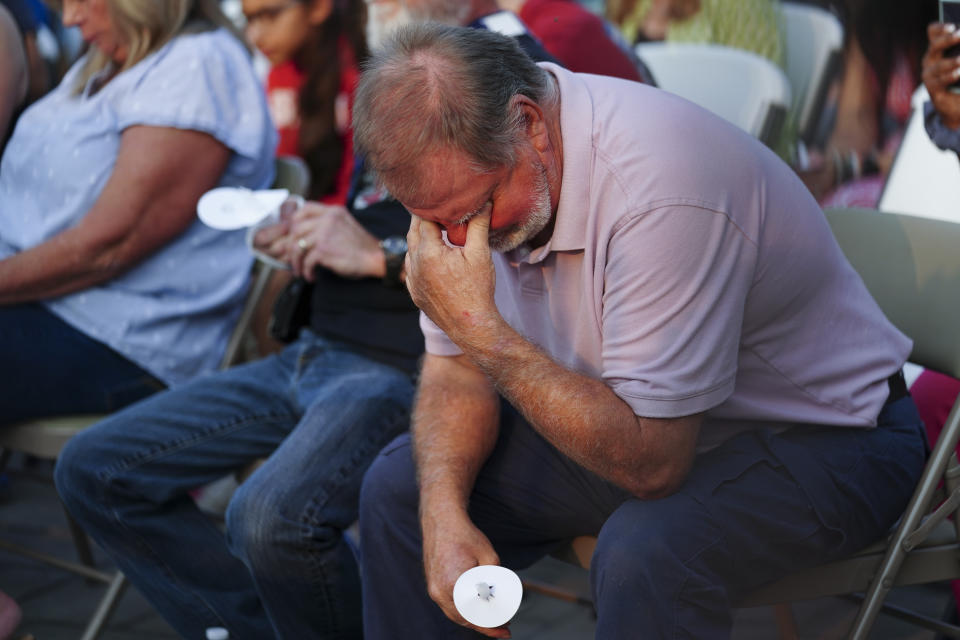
[243, 0, 367, 205]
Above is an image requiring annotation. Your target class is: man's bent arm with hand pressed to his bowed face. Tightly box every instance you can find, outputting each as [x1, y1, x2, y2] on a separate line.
[407, 210, 702, 499]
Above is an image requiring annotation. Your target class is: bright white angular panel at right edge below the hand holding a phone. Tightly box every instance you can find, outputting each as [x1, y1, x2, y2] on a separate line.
[879, 85, 960, 222]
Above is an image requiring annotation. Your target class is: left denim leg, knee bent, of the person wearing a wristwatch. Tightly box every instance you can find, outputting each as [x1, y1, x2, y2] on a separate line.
[55, 347, 298, 640]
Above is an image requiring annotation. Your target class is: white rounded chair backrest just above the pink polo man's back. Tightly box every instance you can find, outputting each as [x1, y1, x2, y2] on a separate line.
[636, 42, 791, 145]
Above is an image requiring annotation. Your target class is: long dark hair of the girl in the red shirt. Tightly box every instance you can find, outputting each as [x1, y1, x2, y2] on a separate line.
[297, 0, 368, 198]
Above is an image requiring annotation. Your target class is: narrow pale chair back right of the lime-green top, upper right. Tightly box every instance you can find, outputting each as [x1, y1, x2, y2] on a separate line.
[780, 2, 843, 144]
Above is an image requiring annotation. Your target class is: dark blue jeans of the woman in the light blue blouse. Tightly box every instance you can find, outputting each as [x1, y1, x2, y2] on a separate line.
[0, 304, 164, 425]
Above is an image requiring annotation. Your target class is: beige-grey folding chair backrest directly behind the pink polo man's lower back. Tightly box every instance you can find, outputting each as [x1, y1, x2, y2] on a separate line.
[825, 209, 960, 378]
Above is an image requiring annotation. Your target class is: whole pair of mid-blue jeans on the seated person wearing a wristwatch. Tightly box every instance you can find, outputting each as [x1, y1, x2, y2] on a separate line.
[56, 331, 413, 640]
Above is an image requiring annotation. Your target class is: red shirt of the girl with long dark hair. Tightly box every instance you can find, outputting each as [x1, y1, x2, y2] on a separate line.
[267, 40, 360, 204]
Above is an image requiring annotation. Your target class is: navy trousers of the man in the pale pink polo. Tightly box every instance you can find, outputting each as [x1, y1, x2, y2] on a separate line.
[360, 397, 925, 640]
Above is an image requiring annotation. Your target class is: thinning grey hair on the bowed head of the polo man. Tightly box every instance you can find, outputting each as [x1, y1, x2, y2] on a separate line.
[353, 23, 556, 200]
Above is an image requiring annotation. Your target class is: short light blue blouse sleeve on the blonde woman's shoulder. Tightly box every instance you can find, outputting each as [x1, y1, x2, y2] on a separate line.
[113, 29, 276, 165]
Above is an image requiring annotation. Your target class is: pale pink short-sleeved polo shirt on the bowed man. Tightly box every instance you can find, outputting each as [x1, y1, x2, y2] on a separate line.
[421, 63, 911, 450]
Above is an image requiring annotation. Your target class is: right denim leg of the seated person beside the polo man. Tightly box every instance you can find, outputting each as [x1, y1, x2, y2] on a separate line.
[227, 349, 413, 639]
